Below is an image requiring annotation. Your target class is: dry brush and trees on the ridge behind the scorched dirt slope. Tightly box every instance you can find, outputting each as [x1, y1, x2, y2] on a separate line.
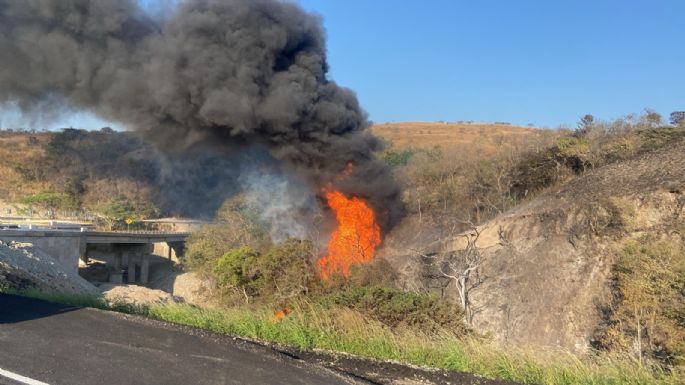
[379, 110, 685, 234]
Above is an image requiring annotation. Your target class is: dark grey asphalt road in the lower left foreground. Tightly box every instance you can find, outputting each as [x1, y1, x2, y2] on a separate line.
[0, 294, 358, 385]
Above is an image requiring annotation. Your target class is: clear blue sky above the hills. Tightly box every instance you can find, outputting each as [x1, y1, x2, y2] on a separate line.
[0, 0, 685, 128]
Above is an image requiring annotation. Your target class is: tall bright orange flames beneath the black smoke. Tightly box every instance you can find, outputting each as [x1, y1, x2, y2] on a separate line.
[317, 187, 381, 280]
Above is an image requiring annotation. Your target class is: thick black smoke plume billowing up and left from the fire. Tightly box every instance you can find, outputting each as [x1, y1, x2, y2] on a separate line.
[0, 0, 402, 227]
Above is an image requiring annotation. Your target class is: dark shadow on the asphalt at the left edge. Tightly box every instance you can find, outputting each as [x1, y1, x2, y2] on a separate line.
[0, 293, 80, 324]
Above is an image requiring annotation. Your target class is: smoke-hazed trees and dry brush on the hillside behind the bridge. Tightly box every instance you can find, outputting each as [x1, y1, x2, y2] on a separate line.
[0, 127, 240, 220]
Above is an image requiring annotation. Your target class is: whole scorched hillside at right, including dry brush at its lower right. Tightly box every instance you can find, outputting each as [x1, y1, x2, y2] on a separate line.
[388, 139, 685, 354]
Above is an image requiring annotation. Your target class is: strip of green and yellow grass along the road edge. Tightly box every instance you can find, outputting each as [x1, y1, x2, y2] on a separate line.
[4, 292, 683, 385]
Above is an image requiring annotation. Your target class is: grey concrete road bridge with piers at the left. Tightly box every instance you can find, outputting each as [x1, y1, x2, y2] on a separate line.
[0, 229, 190, 284]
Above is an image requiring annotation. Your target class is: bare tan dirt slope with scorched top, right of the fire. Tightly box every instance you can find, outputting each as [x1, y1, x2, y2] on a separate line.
[394, 140, 685, 349]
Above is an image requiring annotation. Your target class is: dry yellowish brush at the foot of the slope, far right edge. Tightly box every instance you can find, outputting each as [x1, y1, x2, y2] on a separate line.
[599, 236, 685, 365]
